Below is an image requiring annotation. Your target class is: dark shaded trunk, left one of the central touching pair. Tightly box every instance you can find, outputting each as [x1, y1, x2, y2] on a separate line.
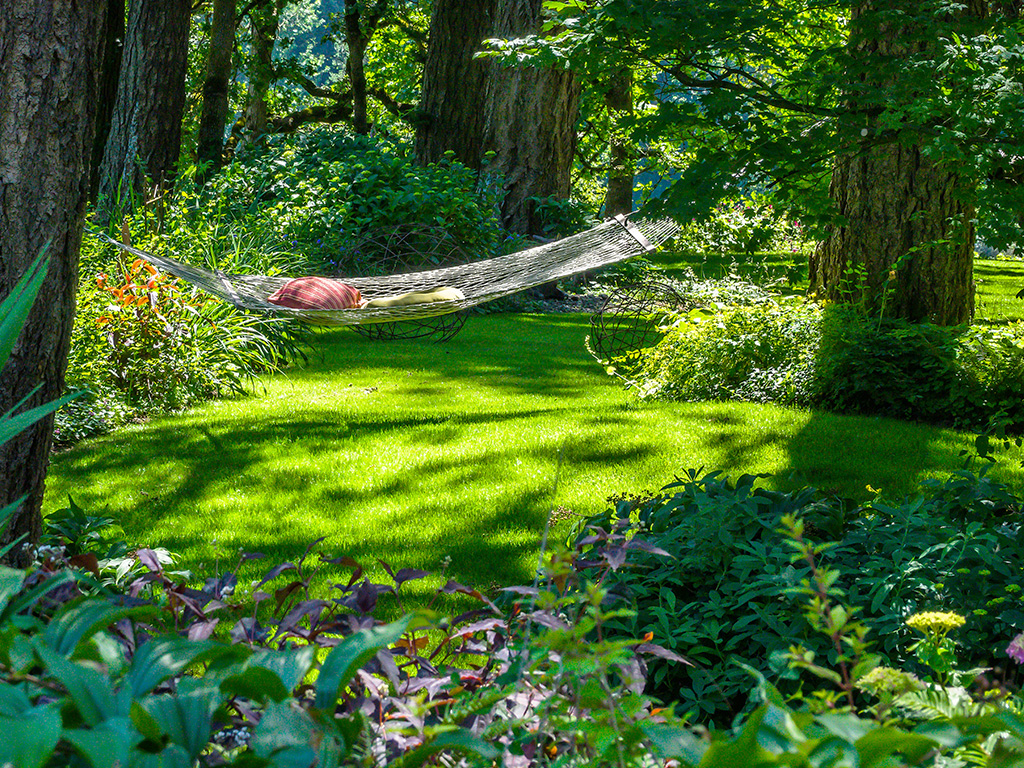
[416, 0, 496, 170]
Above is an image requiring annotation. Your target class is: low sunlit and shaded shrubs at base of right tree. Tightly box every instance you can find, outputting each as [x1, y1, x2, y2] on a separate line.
[622, 284, 1024, 432]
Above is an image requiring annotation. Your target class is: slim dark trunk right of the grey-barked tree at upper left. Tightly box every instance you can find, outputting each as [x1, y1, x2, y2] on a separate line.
[196, 0, 234, 179]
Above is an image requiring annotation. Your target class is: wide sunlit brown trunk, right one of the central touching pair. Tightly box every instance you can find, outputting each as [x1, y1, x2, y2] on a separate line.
[483, 0, 580, 234]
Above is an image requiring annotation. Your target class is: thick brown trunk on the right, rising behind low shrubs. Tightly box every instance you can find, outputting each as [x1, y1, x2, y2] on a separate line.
[810, 0, 985, 325]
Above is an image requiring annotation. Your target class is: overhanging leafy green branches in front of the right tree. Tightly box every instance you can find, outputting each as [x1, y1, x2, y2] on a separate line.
[501, 0, 1024, 245]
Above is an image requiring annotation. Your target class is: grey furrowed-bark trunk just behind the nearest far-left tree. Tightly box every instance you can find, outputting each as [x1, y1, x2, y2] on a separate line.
[99, 0, 191, 219]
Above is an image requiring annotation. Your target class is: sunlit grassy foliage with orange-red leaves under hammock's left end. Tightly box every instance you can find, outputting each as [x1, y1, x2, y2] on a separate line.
[64, 243, 299, 428]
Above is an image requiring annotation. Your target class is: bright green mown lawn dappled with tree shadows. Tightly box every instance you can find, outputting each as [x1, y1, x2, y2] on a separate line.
[45, 301, 1024, 602]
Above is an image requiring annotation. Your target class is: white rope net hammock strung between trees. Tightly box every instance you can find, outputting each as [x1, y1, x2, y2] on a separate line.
[96, 216, 679, 326]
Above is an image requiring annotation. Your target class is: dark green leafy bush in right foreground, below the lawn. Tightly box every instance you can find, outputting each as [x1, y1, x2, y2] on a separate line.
[588, 472, 1024, 723]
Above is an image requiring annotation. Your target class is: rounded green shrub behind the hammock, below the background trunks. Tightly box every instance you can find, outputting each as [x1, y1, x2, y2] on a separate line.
[186, 128, 503, 274]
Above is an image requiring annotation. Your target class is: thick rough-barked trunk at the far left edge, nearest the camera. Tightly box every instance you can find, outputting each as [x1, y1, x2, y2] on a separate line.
[0, 0, 106, 564]
